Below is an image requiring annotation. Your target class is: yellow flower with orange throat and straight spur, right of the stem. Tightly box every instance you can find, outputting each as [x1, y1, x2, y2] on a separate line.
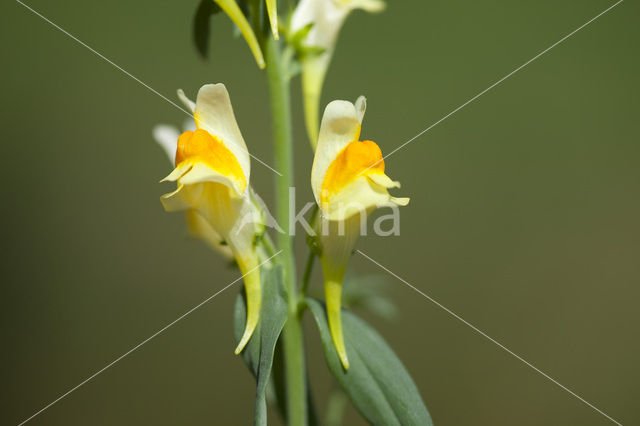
[311, 96, 409, 369]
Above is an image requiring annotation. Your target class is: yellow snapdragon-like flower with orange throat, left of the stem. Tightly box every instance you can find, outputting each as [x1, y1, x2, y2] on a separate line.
[161, 84, 263, 353]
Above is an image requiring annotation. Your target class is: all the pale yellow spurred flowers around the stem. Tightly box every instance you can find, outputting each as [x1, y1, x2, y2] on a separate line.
[154, 0, 400, 370]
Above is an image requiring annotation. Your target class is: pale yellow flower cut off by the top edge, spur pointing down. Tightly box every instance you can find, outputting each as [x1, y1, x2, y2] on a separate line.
[290, 0, 385, 148]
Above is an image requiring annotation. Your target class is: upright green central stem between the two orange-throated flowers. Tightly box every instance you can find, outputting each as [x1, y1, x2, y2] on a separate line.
[265, 37, 307, 426]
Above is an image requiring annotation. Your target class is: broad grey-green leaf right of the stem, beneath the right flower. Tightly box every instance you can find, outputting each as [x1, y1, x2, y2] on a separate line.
[304, 298, 433, 426]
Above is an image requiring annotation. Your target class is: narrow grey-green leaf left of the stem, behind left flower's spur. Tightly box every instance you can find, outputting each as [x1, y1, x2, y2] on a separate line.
[233, 266, 287, 426]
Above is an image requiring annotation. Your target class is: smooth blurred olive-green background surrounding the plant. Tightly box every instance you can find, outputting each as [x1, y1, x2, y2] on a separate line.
[0, 0, 640, 425]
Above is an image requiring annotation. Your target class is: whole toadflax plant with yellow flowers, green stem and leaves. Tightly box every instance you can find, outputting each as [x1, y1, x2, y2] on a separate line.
[154, 0, 432, 426]
